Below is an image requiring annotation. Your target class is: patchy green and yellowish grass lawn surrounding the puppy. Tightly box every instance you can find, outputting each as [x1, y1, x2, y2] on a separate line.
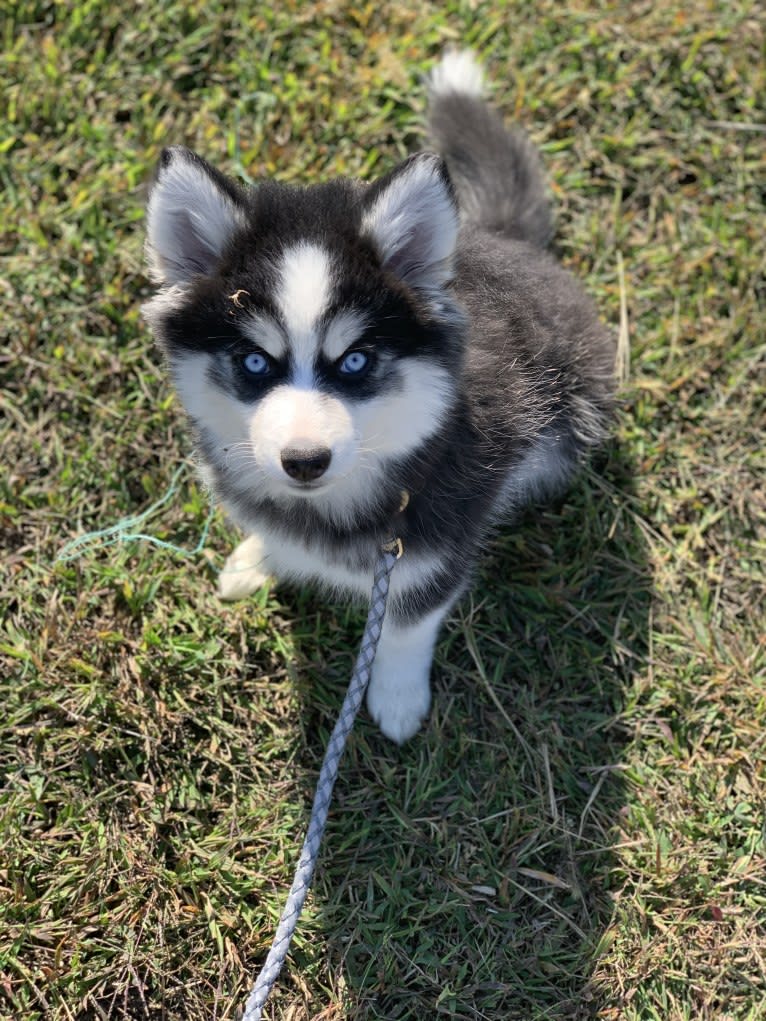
[0, 0, 766, 1021]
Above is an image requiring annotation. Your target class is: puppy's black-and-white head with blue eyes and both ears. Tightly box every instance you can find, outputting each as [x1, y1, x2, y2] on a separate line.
[144, 149, 462, 517]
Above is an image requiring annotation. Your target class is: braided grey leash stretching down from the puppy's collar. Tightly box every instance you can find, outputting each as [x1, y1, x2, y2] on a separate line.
[242, 539, 401, 1021]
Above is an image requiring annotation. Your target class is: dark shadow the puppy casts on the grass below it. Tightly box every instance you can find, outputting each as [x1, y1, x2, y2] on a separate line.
[273, 443, 651, 1021]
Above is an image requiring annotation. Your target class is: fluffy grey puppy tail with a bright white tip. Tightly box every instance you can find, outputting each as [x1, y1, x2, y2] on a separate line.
[428, 50, 553, 247]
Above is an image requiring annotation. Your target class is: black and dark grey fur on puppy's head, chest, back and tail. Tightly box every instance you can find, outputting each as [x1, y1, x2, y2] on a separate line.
[145, 83, 614, 620]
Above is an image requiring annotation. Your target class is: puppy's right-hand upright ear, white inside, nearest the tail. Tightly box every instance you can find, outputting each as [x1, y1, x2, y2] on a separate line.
[362, 153, 459, 291]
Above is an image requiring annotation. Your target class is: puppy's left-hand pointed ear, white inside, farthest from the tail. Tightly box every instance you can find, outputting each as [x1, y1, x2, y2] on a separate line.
[146, 145, 246, 286]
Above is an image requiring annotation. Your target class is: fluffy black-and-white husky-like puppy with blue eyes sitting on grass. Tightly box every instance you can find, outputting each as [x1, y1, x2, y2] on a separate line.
[143, 52, 615, 741]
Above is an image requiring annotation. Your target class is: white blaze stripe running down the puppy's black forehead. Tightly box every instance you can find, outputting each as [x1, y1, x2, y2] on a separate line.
[275, 241, 333, 366]
